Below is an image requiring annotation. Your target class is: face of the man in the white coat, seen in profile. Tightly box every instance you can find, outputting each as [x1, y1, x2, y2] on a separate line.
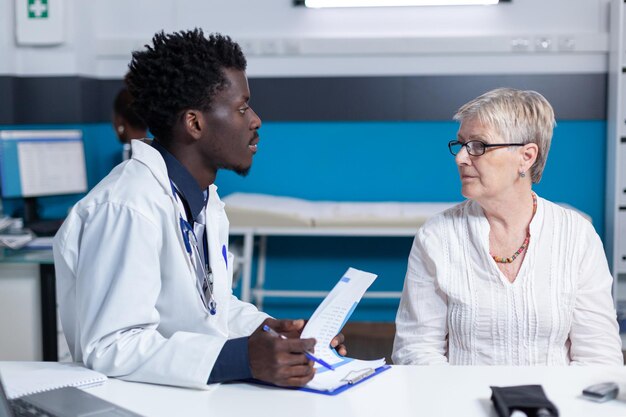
[200, 69, 261, 175]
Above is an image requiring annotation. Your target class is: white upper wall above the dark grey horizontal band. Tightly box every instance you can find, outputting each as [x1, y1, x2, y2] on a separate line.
[0, 0, 619, 78]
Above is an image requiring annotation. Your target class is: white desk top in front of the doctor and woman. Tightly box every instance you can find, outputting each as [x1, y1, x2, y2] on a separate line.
[88, 366, 626, 417]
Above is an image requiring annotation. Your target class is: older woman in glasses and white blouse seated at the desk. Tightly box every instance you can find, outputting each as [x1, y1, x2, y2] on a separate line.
[393, 88, 623, 365]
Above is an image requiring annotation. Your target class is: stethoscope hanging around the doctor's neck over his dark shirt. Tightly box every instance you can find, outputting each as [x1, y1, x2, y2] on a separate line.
[170, 180, 217, 315]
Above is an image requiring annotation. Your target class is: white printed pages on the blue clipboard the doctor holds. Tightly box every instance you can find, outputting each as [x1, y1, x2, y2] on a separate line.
[301, 268, 385, 392]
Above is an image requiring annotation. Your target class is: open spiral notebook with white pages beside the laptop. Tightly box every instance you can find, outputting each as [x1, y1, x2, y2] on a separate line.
[0, 362, 107, 399]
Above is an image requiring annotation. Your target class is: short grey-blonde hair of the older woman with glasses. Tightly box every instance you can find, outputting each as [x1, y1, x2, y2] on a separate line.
[454, 88, 556, 183]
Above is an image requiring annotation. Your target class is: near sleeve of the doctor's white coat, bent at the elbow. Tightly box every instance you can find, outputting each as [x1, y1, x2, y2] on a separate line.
[57, 203, 225, 388]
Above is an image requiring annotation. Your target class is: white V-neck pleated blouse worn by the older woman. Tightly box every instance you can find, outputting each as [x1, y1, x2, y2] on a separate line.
[393, 198, 623, 365]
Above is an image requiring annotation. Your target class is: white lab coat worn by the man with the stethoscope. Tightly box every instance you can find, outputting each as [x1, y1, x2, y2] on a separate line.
[54, 141, 268, 387]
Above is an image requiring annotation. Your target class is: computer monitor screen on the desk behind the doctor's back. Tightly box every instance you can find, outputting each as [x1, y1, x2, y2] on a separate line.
[0, 130, 87, 198]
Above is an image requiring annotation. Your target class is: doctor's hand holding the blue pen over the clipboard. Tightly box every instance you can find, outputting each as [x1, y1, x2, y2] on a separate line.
[248, 319, 315, 387]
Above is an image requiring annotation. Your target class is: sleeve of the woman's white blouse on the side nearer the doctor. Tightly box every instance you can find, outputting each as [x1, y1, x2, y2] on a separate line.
[392, 223, 448, 365]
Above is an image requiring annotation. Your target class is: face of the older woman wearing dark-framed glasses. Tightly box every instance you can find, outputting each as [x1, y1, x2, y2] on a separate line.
[455, 119, 521, 201]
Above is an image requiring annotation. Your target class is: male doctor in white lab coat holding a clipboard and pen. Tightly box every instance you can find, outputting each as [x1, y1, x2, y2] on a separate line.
[54, 29, 345, 387]
